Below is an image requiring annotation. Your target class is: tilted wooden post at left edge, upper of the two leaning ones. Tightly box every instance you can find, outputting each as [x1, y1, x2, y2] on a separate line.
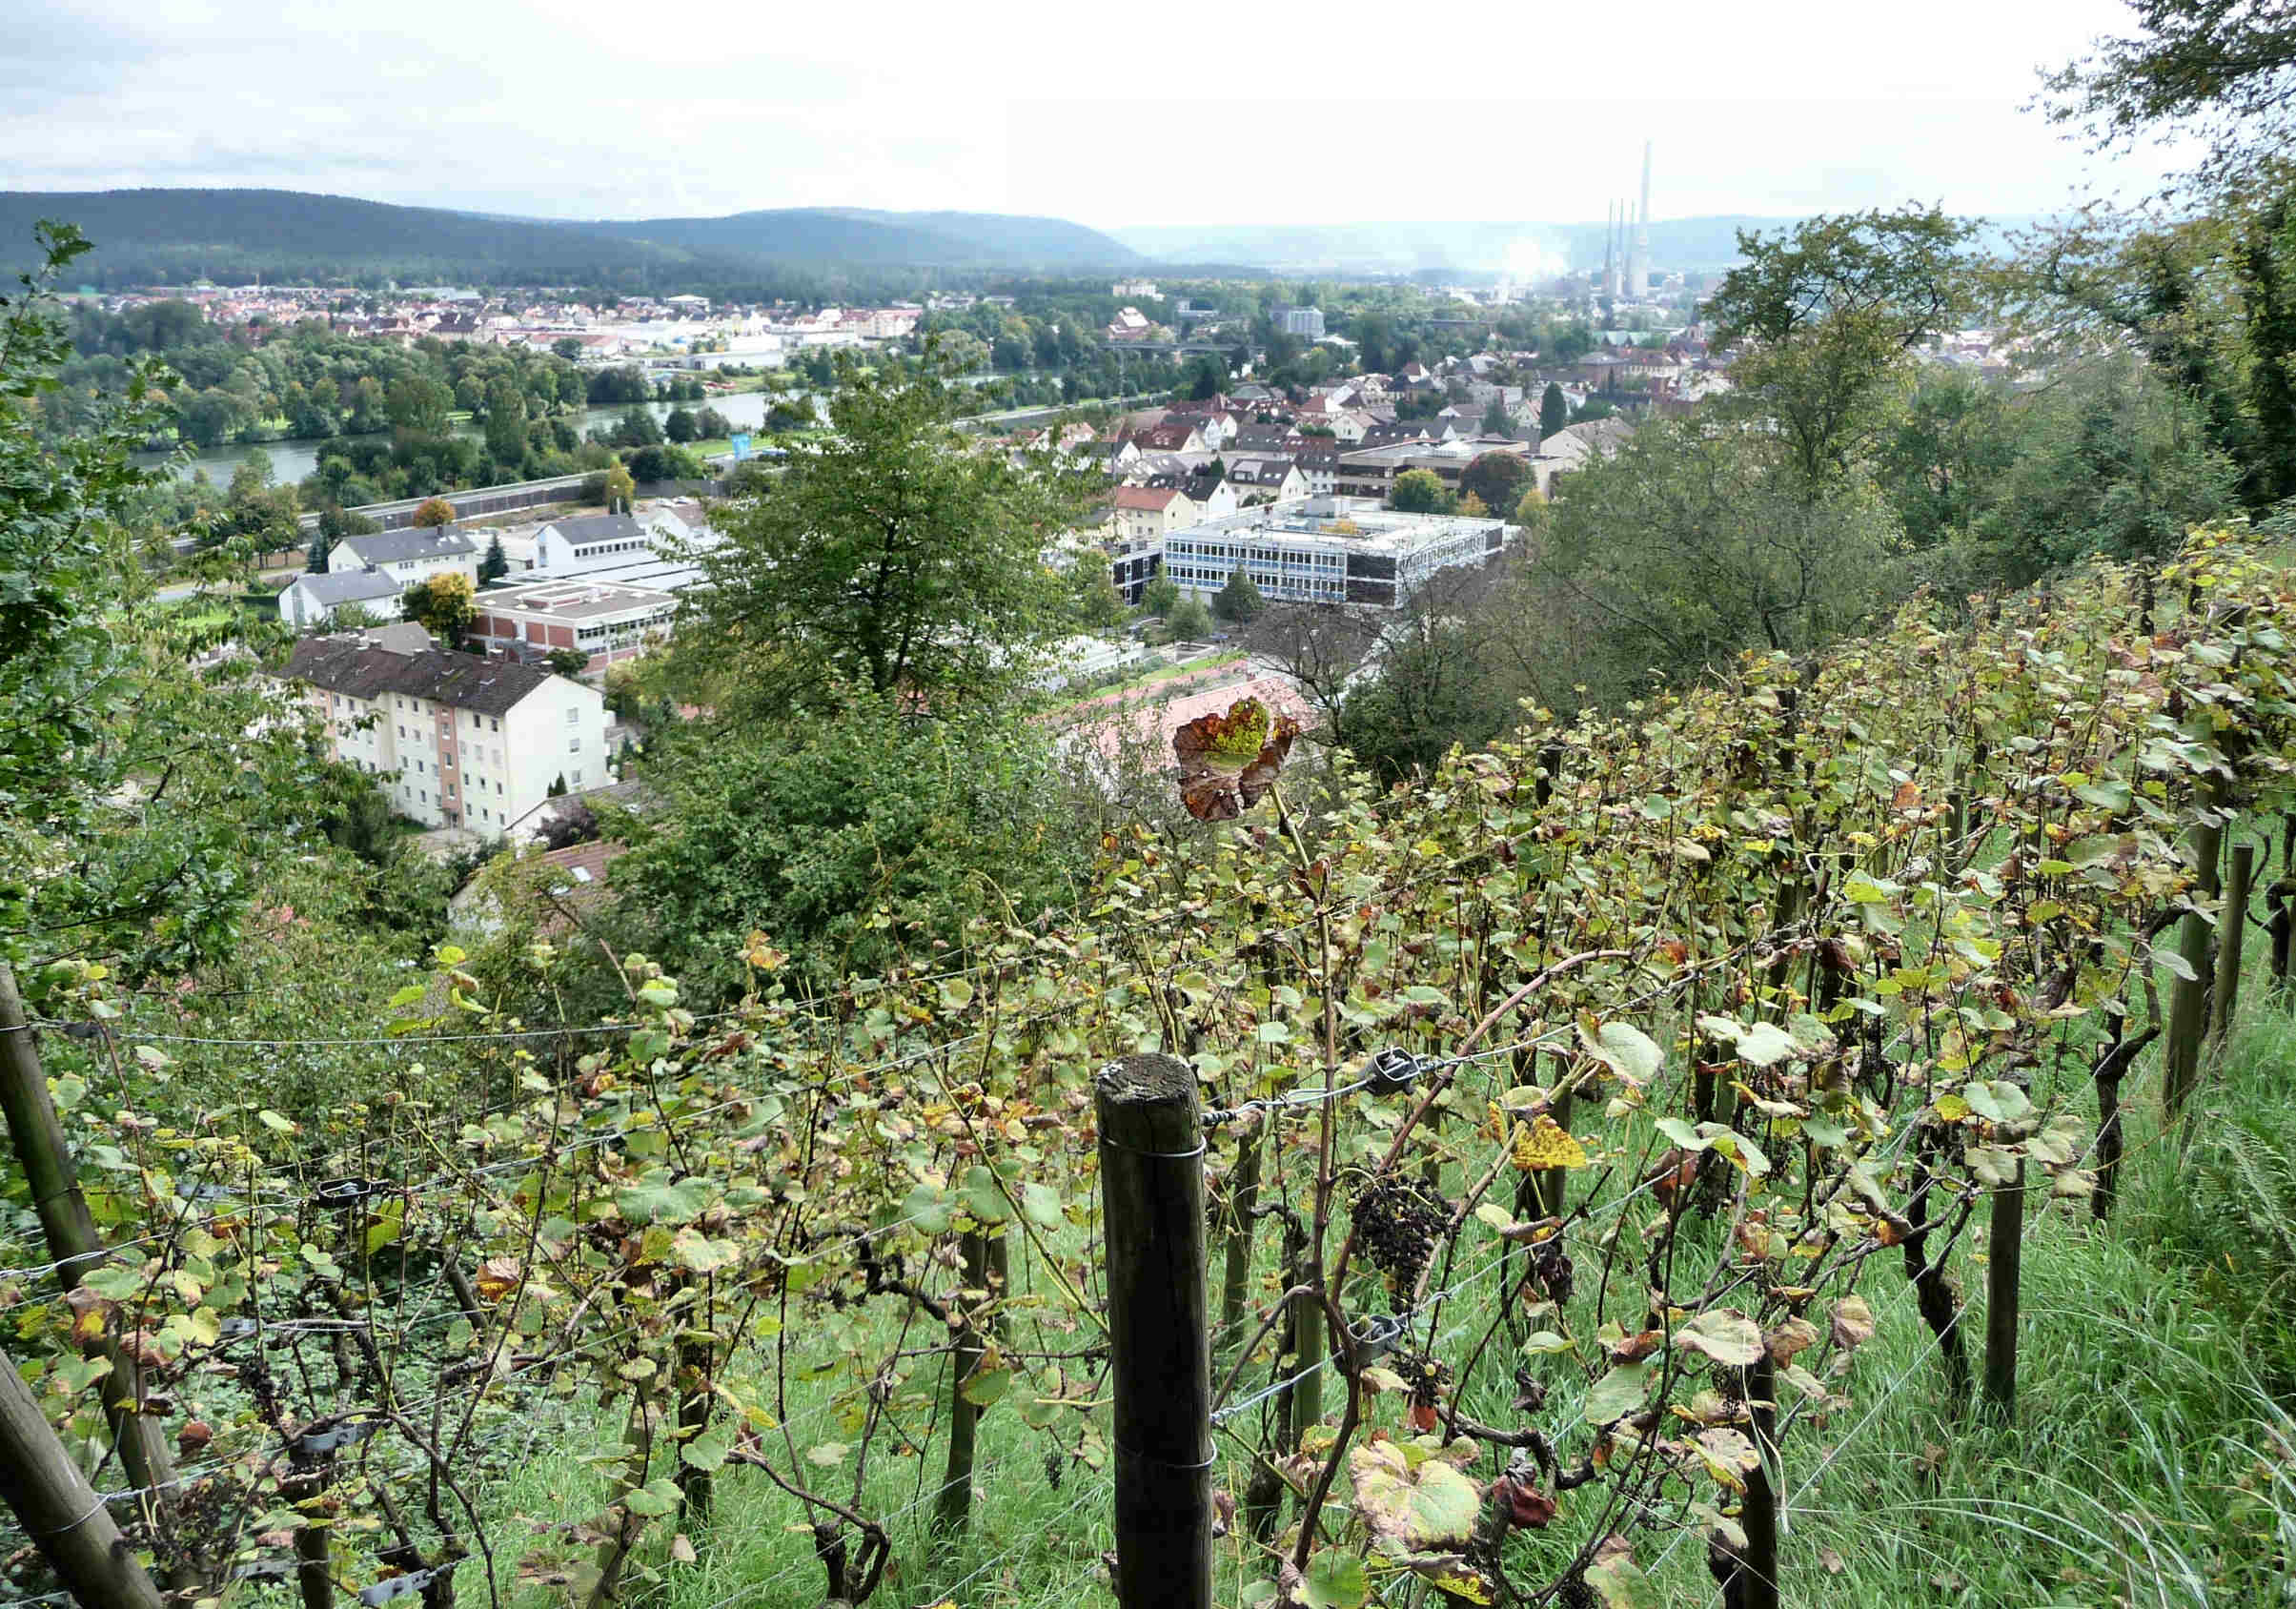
[0, 962, 174, 1513]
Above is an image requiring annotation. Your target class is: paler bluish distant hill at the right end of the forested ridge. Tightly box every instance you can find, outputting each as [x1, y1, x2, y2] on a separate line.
[567, 207, 1141, 269]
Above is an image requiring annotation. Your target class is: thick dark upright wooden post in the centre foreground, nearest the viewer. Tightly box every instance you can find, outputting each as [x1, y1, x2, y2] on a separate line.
[1093, 1056, 1212, 1609]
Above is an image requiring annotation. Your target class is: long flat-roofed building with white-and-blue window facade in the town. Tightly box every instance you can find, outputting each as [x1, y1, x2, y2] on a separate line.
[1162, 496, 1511, 608]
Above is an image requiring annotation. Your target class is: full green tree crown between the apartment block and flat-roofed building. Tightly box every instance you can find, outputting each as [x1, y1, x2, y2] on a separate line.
[680, 367, 1093, 711]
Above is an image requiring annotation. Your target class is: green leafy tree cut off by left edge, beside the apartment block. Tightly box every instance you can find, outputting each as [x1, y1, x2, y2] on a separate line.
[0, 223, 323, 977]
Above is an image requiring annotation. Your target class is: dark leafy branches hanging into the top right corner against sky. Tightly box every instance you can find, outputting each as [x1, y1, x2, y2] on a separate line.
[2043, 0, 2296, 186]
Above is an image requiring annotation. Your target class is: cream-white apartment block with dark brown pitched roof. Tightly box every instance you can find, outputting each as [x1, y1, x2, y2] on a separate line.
[282, 622, 608, 836]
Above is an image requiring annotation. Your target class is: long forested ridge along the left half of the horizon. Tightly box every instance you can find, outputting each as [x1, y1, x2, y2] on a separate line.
[0, 191, 1136, 294]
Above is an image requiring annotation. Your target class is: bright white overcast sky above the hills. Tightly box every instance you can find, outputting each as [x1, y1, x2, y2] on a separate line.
[0, 0, 2177, 227]
